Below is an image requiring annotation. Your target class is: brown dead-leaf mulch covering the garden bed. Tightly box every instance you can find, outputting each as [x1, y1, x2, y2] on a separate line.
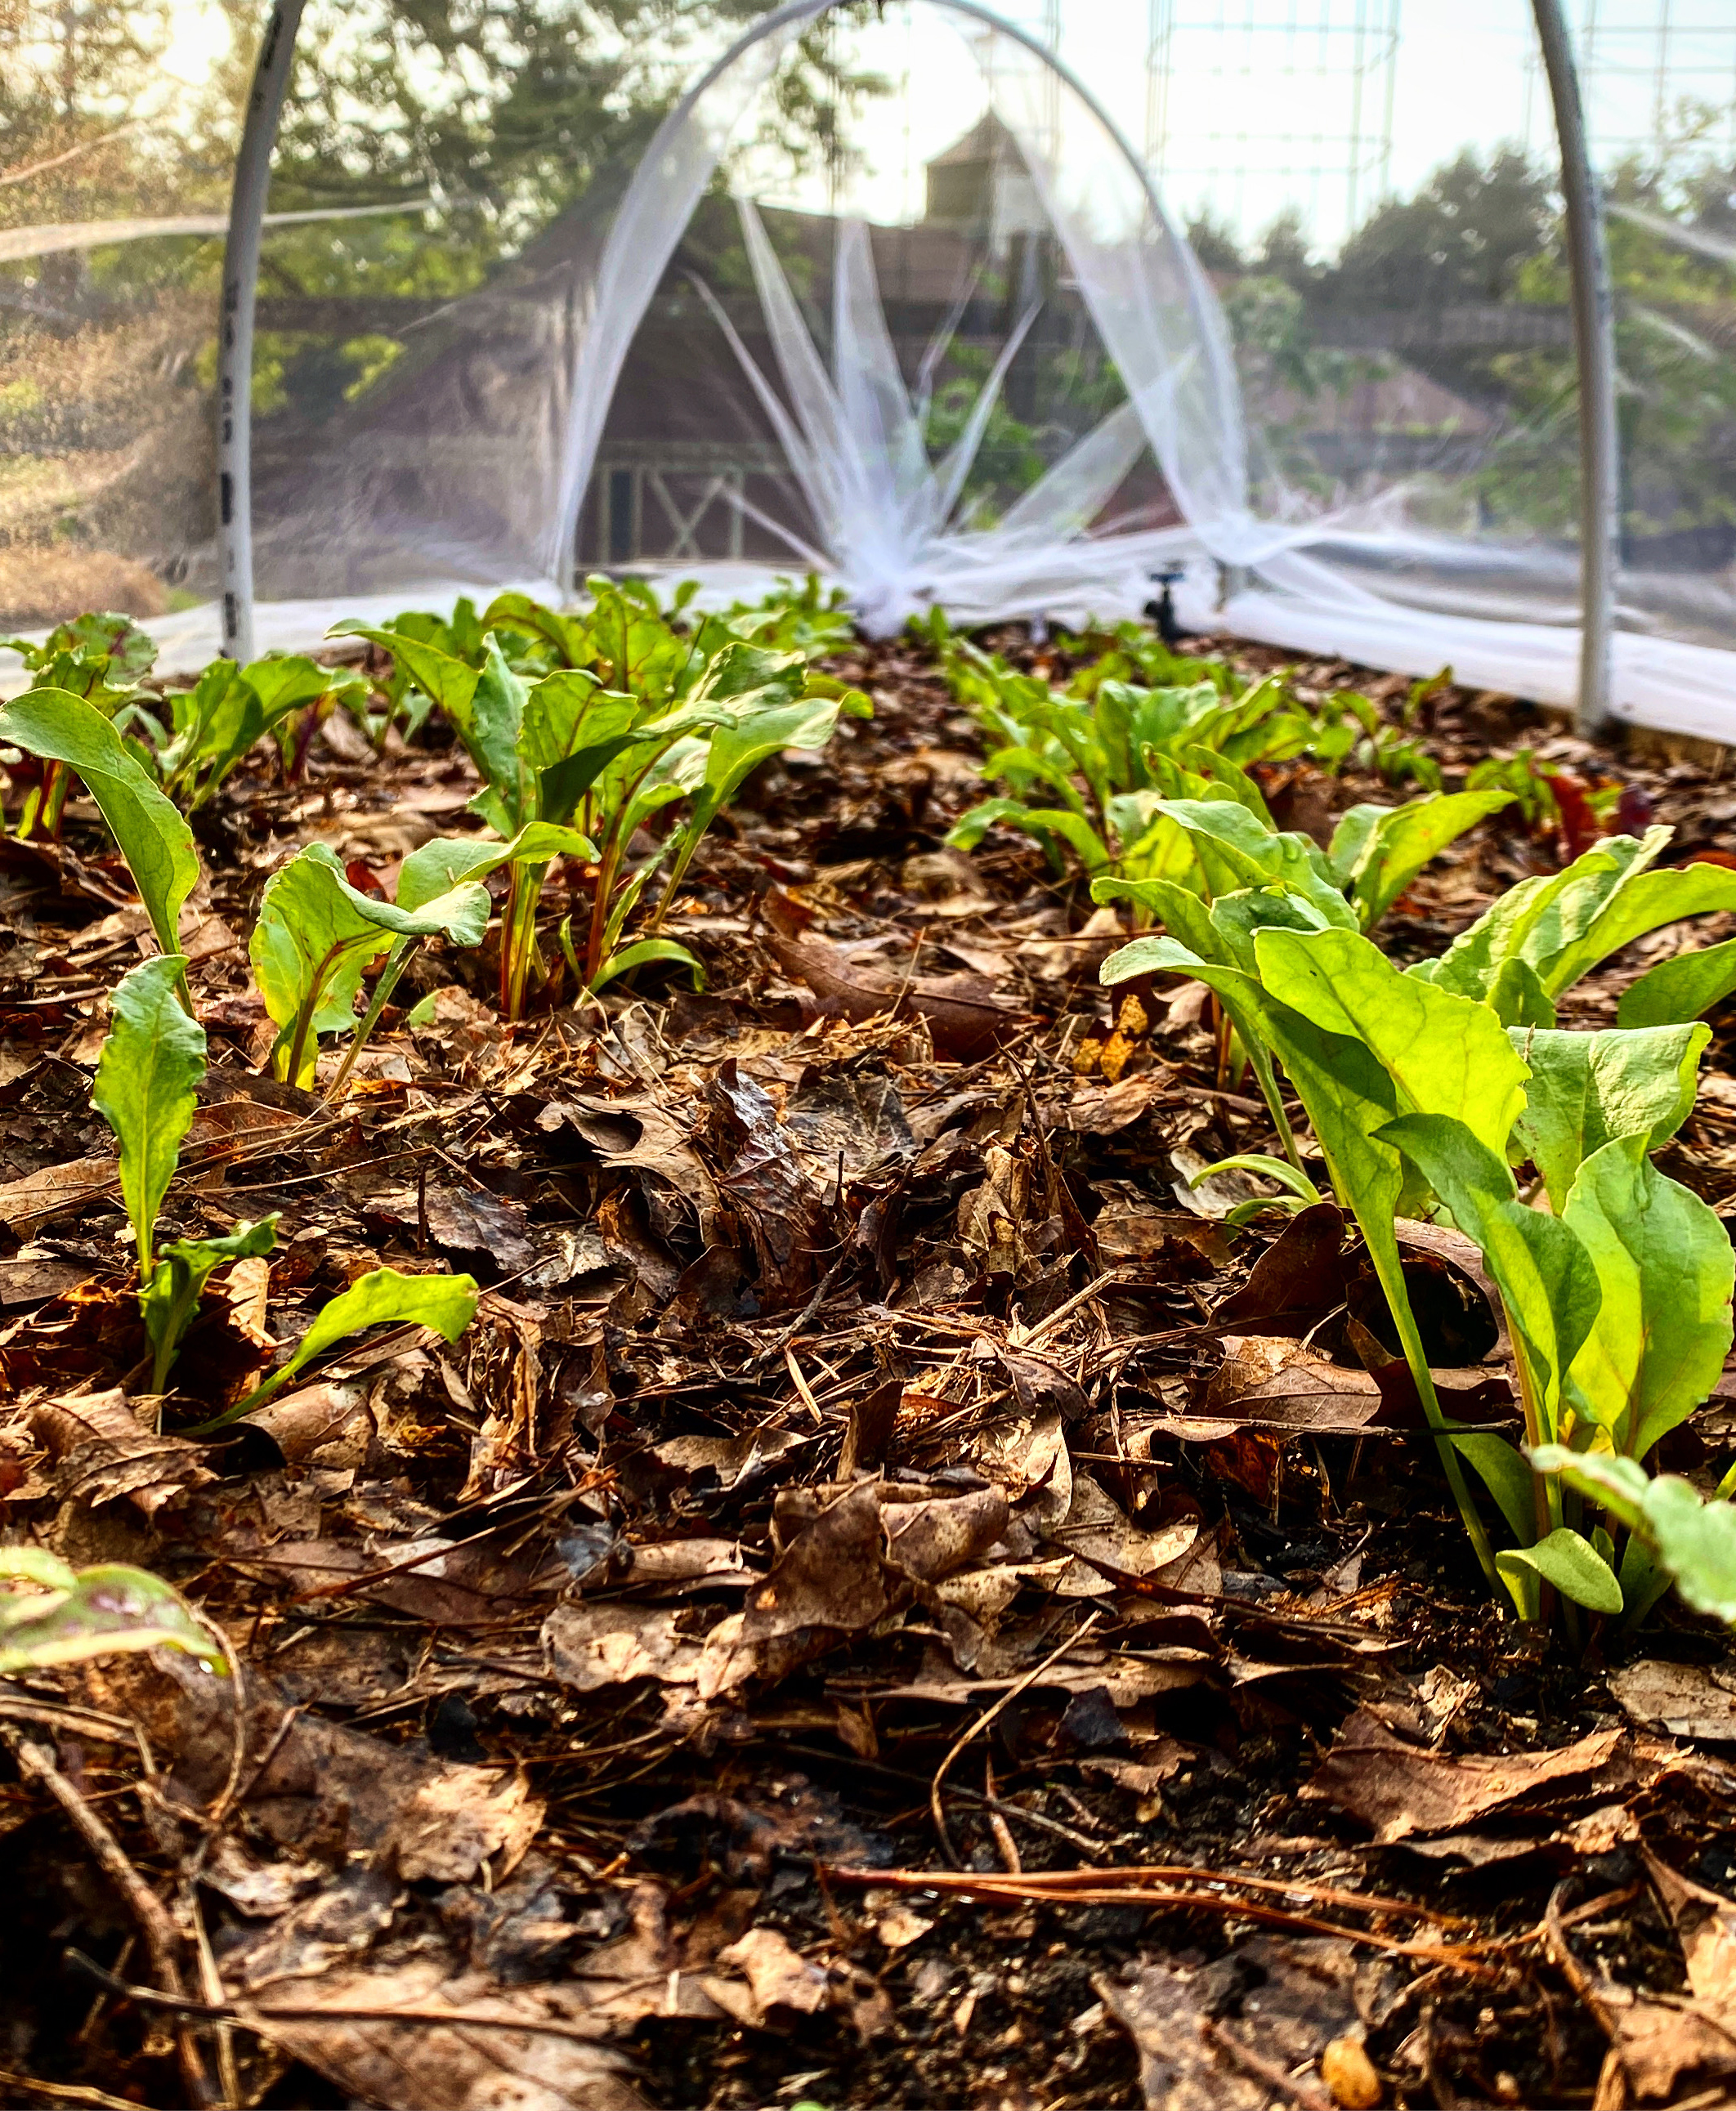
[0, 637, 1736, 2111]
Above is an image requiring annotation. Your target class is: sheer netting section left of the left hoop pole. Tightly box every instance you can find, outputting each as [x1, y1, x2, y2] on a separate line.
[0, 0, 251, 627]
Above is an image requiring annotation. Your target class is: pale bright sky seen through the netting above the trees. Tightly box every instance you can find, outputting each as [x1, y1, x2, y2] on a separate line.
[145, 0, 1736, 253]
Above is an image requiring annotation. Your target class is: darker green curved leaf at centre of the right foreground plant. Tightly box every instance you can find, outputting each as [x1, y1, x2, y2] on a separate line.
[1381, 1115, 1603, 1444]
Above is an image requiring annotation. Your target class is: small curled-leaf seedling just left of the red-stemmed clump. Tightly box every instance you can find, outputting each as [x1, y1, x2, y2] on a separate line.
[247, 843, 490, 1089]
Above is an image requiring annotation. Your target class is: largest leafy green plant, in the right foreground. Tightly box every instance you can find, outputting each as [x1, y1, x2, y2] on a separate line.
[1098, 874, 1736, 1619]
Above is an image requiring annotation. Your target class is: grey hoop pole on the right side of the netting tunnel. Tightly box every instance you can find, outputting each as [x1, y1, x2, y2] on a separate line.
[1531, 0, 1620, 739]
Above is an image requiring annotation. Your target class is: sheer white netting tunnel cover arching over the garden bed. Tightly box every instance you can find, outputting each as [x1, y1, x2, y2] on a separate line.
[0, 0, 1736, 736]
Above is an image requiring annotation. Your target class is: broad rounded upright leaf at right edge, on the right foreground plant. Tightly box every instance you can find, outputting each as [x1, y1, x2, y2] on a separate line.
[1563, 1131, 1736, 1459]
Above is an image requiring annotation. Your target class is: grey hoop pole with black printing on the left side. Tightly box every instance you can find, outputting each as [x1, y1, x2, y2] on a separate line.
[217, 0, 304, 660]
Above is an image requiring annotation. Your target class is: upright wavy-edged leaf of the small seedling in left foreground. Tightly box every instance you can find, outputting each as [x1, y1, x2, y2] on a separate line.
[91, 952, 205, 1283]
